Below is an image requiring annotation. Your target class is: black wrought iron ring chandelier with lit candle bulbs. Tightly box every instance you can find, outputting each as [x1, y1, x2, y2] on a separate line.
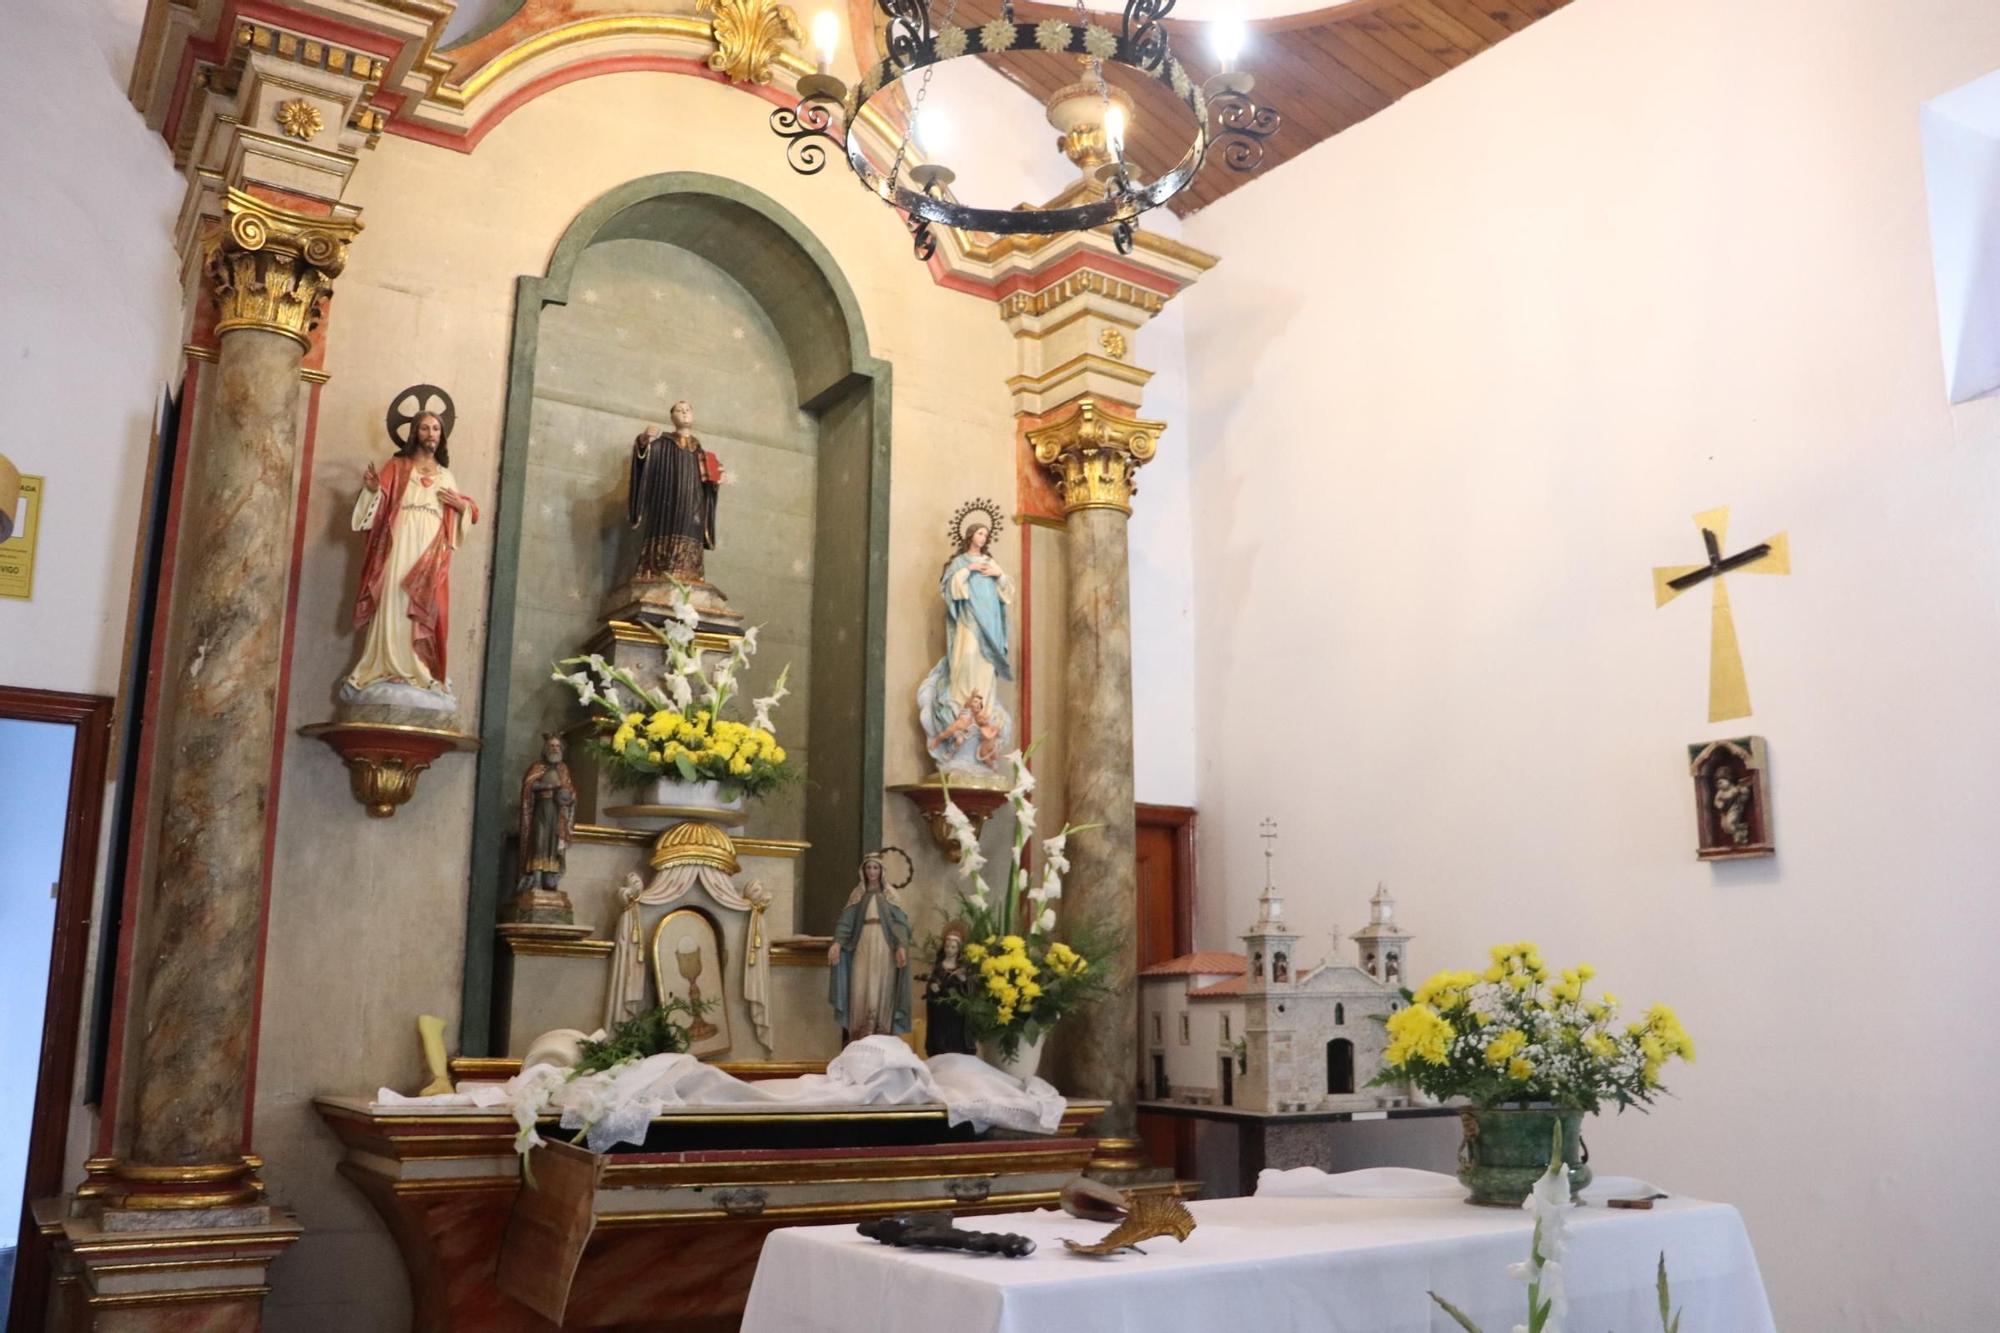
[770, 0, 1280, 260]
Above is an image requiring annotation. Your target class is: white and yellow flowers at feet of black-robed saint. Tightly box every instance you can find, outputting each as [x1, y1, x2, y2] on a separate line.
[554, 582, 798, 797]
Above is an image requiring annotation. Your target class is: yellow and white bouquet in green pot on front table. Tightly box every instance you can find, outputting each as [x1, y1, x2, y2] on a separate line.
[1374, 943, 1694, 1113]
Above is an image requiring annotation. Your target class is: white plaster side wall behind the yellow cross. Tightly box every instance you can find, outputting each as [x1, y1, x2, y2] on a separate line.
[1184, 0, 2000, 1331]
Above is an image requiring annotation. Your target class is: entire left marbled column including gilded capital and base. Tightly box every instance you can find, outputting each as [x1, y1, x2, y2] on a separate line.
[126, 190, 358, 1184]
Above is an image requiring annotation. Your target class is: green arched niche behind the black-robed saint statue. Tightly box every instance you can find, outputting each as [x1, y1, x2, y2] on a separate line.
[462, 172, 890, 1051]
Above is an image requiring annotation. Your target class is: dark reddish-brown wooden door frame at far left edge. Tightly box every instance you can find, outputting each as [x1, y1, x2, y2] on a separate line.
[0, 687, 112, 1329]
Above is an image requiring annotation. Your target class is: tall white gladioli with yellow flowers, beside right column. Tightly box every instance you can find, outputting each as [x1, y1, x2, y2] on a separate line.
[944, 747, 1110, 1061]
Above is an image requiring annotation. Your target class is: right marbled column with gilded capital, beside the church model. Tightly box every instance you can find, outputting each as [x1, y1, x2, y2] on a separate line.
[1028, 396, 1166, 1139]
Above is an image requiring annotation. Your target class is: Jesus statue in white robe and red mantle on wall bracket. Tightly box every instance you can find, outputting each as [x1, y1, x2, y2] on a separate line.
[340, 394, 480, 711]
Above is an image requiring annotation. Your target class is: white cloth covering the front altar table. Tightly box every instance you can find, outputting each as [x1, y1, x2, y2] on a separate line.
[742, 1199, 1774, 1333]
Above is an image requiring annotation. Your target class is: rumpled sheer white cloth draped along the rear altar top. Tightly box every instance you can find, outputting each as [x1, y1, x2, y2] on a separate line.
[376, 1037, 1066, 1153]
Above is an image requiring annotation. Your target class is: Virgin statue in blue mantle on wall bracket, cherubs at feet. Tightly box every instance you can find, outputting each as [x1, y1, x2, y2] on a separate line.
[916, 500, 1014, 779]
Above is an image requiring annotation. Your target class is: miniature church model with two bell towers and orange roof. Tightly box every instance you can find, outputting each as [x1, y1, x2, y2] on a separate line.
[1140, 872, 1412, 1113]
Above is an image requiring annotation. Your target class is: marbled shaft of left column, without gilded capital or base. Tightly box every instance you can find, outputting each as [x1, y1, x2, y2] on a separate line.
[132, 328, 302, 1165]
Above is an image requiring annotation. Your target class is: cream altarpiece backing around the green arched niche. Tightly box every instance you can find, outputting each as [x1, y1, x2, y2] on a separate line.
[256, 74, 1014, 1331]
